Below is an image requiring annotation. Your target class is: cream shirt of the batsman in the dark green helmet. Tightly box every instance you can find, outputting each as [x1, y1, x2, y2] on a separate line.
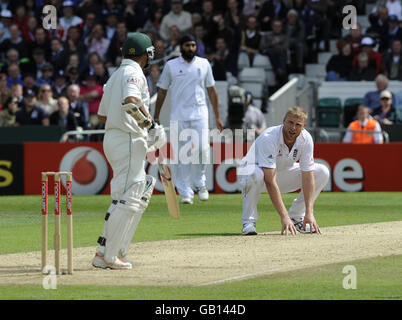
[98, 59, 150, 137]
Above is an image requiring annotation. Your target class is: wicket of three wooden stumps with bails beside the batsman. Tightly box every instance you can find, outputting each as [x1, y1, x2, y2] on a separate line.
[42, 172, 73, 274]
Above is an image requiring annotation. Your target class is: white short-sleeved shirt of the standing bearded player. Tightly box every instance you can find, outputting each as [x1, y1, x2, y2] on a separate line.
[157, 56, 215, 121]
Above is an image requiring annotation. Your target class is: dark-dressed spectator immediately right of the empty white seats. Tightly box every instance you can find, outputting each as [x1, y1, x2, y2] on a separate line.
[260, 19, 289, 84]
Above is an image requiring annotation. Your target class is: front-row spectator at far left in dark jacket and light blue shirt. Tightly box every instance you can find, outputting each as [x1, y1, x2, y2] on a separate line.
[15, 91, 49, 126]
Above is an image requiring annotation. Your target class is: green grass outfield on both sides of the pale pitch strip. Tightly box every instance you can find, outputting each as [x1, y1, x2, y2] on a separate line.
[0, 192, 402, 300]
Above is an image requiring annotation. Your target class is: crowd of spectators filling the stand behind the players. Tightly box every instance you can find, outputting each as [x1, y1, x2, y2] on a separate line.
[0, 0, 402, 134]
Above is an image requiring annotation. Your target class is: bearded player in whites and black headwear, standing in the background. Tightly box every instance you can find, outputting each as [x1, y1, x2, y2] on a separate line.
[154, 35, 223, 204]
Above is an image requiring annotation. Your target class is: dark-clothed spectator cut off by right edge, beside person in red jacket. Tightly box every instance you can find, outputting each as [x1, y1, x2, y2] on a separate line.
[381, 39, 402, 81]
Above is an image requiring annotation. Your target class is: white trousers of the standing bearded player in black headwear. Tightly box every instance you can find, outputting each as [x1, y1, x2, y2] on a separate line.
[174, 119, 209, 198]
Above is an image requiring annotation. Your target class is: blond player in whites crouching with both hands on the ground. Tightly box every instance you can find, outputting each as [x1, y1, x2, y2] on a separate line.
[237, 107, 329, 235]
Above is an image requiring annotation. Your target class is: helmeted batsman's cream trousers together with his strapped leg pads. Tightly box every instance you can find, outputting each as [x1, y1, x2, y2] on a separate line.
[97, 130, 147, 262]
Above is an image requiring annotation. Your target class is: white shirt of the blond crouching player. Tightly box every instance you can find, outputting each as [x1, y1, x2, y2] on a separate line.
[242, 125, 314, 171]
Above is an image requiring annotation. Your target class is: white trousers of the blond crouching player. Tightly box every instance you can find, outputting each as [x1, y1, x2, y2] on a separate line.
[239, 163, 329, 224]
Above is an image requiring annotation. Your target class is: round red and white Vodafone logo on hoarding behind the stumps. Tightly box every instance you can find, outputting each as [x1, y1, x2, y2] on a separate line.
[59, 147, 109, 195]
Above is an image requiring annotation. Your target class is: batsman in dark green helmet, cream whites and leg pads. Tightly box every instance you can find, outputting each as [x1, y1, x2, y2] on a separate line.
[92, 32, 166, 269]
